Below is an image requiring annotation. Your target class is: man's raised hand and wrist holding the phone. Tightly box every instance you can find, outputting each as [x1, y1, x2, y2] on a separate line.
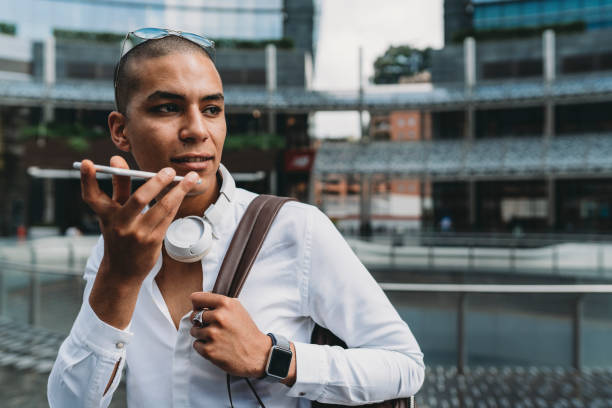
[81, 156, 198, 329]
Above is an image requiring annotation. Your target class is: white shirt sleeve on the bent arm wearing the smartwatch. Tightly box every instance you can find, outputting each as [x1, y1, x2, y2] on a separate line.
[288, 208, 425, 405]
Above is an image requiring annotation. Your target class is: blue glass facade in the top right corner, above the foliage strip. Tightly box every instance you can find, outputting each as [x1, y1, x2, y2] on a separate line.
[473, 0, 612, 30]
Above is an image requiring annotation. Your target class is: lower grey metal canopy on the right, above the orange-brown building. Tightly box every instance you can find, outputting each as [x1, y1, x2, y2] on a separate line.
[314, 134, 612, 180]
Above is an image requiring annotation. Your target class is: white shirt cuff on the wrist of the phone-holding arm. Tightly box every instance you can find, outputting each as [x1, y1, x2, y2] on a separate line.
[73, 301, 133, 358]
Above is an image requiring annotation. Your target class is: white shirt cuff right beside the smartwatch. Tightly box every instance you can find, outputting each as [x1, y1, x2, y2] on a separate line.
[287, 342, 329, 401]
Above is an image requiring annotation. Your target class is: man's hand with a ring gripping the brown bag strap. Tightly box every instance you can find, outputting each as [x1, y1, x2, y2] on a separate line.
[190, 292, 272, 378]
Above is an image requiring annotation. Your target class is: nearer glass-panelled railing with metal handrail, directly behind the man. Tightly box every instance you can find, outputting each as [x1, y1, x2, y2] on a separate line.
[0, 249, 612, 372]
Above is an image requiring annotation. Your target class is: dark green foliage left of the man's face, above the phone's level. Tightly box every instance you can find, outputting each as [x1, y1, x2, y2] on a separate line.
[19, 122, 107, 152]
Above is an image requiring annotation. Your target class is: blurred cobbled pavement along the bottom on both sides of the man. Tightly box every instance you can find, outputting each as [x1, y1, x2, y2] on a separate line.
[0, 366, 612, 408]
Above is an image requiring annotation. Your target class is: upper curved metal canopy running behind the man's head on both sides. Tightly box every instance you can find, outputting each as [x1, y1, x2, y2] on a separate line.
[0, 73, 612, 112]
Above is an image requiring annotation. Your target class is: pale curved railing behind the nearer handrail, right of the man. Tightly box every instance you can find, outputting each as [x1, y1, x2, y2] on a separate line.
[345, 233, 612, 280]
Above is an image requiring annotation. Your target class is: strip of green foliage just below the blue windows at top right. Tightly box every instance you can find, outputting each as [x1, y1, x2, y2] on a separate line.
[452, 21, 586, 43]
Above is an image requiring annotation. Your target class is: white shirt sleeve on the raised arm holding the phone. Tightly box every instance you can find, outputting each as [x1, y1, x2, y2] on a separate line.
[47, 239, 132, 408]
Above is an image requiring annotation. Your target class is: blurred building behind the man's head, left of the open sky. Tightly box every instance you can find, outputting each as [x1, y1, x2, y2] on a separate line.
[0, 0, 317, 235]
